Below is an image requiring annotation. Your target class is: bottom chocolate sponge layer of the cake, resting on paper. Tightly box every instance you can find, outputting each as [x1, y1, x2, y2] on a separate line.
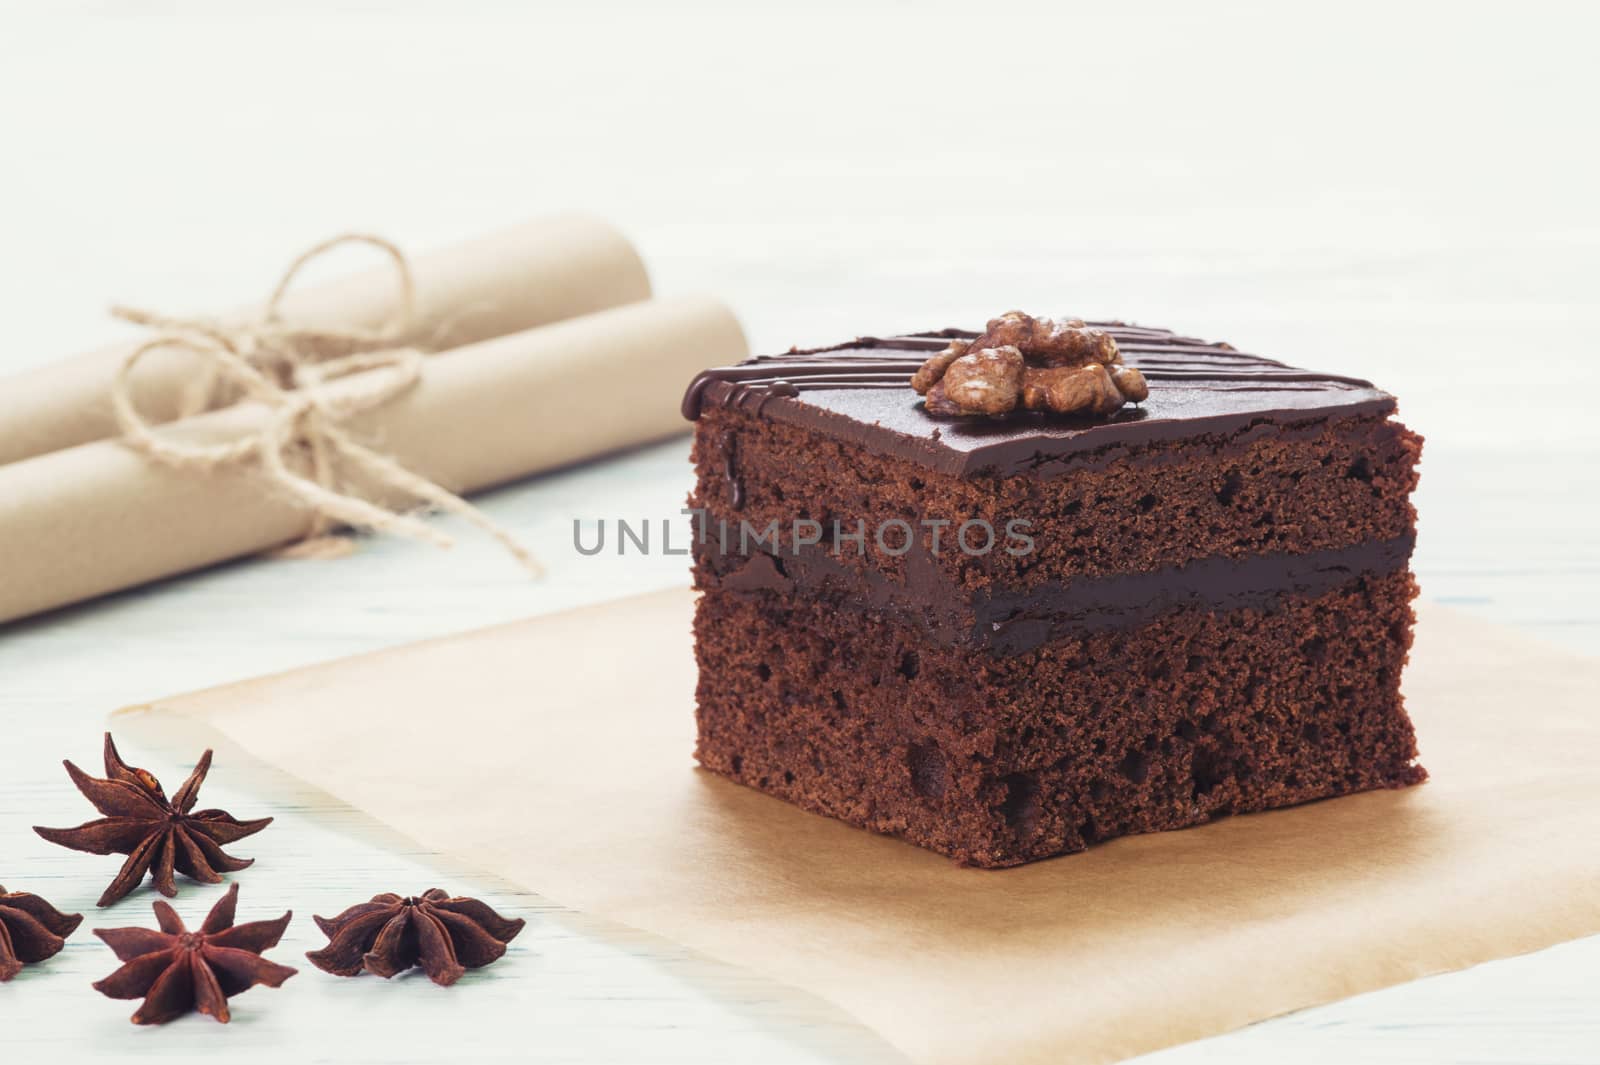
[694, 569, 1426, 867]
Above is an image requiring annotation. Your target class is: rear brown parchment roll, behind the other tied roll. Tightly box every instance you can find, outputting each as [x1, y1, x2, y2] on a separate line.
[0, 214, 650, 465]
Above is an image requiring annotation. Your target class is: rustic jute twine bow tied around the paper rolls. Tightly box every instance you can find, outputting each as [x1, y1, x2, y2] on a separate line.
[110, 233, 542, 576]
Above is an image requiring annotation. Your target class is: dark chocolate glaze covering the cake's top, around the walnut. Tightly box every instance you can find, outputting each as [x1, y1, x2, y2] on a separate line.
[683, 321, 1395, 477]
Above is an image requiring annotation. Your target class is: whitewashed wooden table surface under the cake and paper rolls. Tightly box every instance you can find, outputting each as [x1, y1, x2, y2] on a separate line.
[0, 3, 1600, 1065]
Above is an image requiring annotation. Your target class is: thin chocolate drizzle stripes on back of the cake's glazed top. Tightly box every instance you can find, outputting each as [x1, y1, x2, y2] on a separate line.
[683, 321, 1373, 421]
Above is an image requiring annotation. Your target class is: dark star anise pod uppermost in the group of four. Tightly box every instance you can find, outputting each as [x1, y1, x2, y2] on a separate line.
[34, 732, 272, 907]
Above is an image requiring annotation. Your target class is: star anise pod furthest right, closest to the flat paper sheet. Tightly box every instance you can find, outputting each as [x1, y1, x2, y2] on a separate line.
[306, 888, 525, 987]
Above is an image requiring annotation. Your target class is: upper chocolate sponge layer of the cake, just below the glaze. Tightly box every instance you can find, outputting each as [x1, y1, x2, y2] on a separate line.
[691, 409, 1421, 624]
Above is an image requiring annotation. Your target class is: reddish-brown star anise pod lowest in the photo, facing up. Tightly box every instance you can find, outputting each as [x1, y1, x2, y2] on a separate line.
[94, 884, 296, 1025]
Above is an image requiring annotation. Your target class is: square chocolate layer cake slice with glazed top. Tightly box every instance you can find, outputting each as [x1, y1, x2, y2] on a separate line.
[685, 320, 1426, 867]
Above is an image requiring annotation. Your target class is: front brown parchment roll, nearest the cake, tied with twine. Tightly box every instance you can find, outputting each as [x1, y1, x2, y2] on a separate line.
[0, 297, 746, 622]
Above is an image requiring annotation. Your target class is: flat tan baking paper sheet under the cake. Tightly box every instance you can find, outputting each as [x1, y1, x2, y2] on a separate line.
[131, 590, 1600, 1065]
